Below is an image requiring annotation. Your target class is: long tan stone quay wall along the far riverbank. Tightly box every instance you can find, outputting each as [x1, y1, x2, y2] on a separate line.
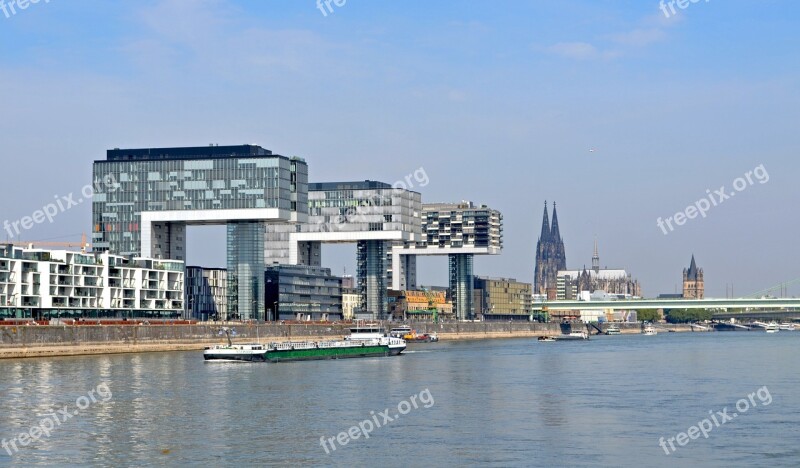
[0, 322, 690, 359]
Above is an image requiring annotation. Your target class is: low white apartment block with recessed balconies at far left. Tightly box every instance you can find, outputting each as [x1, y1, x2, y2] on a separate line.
[0, 245, 184, 319]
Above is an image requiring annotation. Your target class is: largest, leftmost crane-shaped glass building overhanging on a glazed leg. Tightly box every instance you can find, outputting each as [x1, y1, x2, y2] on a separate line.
[92, 145, 308, 320]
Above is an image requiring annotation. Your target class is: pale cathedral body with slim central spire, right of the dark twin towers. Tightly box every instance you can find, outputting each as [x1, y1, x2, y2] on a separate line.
[556, 241, 642, 300]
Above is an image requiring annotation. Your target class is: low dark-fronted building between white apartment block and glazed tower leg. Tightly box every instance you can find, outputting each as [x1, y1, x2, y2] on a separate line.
[184, 266, 228, 321]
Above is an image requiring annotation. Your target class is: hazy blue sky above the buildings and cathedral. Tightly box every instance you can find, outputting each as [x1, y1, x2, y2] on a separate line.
[0, 0, 800, 297]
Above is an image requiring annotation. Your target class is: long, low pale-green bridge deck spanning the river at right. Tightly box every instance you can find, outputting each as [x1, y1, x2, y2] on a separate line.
[533, 298, 800, 312]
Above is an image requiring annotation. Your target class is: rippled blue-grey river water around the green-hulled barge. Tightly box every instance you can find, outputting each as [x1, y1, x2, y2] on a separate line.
[0, 332, 800, 467]
